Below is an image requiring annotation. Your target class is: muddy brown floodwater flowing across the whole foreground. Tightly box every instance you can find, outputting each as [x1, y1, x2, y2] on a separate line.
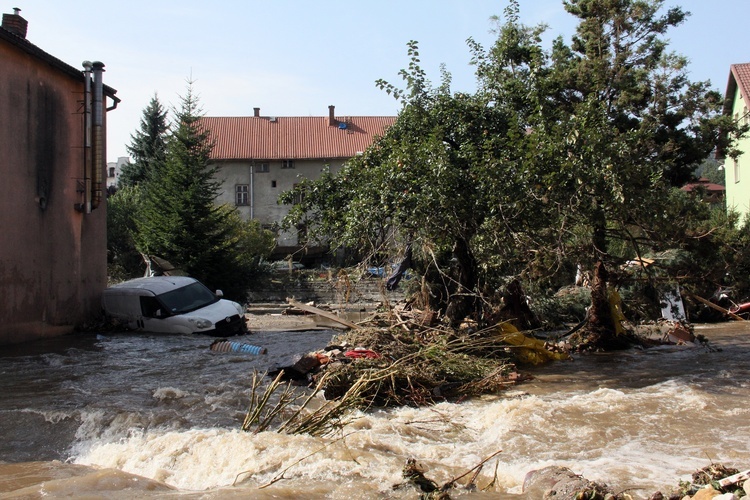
[0, 322, 750, 500]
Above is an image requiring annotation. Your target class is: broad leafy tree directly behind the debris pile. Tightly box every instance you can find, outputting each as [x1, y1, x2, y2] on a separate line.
[282, 36, 542, 325]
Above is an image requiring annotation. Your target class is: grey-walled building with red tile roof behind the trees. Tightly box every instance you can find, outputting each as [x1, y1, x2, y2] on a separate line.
[202, 106, 396, 256]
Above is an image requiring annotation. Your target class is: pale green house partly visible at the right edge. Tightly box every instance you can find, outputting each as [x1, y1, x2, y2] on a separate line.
[724, 63, 750, 218]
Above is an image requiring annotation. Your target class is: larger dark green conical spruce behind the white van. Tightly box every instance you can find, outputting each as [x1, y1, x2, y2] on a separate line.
[136, 82, 262, 300]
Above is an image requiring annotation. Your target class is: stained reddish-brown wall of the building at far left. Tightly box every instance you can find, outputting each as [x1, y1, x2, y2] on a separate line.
[0, 40, 107, 344]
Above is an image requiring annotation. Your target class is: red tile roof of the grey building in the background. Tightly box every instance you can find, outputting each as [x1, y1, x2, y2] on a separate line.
[201, 116, 396, 160]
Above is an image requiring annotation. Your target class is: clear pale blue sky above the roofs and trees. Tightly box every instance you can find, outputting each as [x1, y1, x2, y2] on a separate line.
[10, 0, 750, 161]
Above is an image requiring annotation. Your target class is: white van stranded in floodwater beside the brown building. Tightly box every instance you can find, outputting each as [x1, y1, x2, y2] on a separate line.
[102, 276, 247, 337]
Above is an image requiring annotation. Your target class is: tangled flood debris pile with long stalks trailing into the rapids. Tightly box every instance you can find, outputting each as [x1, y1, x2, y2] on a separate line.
[242, 305, 568, 435]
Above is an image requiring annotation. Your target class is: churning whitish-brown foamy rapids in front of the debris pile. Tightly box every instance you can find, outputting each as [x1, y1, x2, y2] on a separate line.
[76, 383, 718, 492]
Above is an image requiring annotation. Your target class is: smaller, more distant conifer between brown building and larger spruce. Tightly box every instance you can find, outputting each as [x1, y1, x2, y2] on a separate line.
[118, 95, 169, 187]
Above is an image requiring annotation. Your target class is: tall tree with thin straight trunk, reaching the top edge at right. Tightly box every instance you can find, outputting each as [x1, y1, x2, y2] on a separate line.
[532, 0, 748, 346]
